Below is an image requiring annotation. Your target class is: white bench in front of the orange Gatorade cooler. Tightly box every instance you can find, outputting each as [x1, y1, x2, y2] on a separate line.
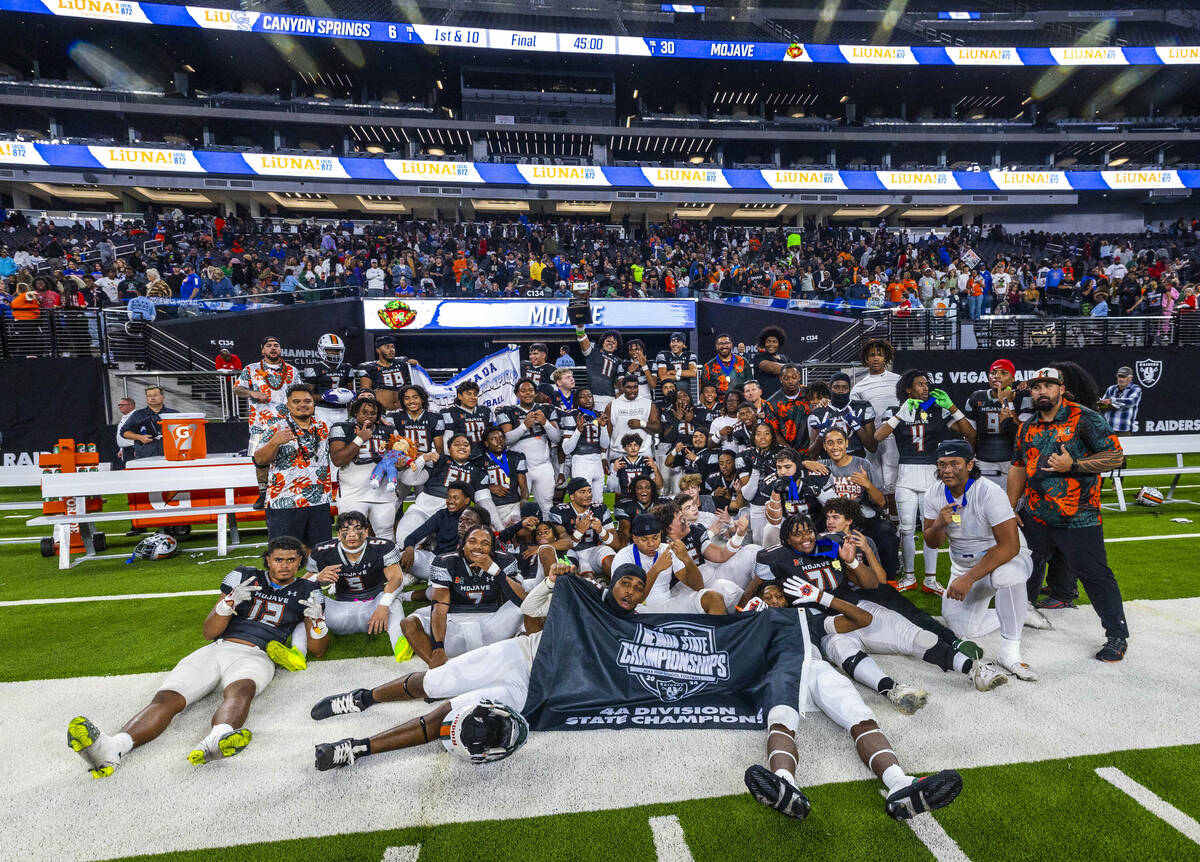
[25, 457, 258, 569]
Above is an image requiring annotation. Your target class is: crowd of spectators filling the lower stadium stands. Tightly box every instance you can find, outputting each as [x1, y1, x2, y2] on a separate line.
[7, 210, 1200, 319]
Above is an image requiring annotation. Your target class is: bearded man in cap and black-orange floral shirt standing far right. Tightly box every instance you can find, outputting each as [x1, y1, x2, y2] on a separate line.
[1008, 367, 1129, 662]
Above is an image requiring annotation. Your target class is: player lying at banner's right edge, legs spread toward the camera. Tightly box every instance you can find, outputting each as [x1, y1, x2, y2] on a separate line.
[745, 576, 962, 820]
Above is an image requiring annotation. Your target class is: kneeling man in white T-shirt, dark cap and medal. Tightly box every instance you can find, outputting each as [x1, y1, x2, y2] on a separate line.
[920, 439, 1044, 682]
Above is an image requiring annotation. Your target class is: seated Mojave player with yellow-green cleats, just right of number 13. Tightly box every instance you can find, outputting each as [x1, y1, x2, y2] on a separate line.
[292, 510, 413, 662]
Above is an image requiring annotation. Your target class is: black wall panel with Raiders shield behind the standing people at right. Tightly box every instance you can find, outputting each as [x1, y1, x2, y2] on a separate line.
[892, 346, 1200, 435]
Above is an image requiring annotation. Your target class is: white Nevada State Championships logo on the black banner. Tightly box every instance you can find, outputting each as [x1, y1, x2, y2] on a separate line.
[617, 622, 730, 702]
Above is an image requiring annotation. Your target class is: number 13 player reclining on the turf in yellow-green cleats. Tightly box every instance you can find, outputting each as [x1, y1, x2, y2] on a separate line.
[67, 535, 329, 778]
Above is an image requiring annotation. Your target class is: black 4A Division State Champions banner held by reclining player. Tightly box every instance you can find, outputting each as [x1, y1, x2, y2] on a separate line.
[522, 576, 805, 730]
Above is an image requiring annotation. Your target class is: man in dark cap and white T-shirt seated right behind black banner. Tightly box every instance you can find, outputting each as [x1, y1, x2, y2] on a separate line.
[612, 511, 725, 615]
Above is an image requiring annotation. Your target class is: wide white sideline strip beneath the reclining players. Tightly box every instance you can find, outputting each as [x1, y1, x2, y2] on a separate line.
[7, 598, 1200, 861]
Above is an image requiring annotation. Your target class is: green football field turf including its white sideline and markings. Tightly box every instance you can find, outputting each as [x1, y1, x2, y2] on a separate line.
[0, 461, 1200, 862]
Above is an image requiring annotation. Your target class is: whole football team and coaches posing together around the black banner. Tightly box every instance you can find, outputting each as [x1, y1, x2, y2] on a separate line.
[68, 328, 1128, 818]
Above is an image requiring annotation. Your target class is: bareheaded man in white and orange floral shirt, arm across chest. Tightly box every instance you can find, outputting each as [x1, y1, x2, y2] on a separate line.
[254, 383, 334, 547]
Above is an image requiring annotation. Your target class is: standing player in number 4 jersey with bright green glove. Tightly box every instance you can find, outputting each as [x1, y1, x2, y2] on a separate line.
[875, 369, 974, 595]
